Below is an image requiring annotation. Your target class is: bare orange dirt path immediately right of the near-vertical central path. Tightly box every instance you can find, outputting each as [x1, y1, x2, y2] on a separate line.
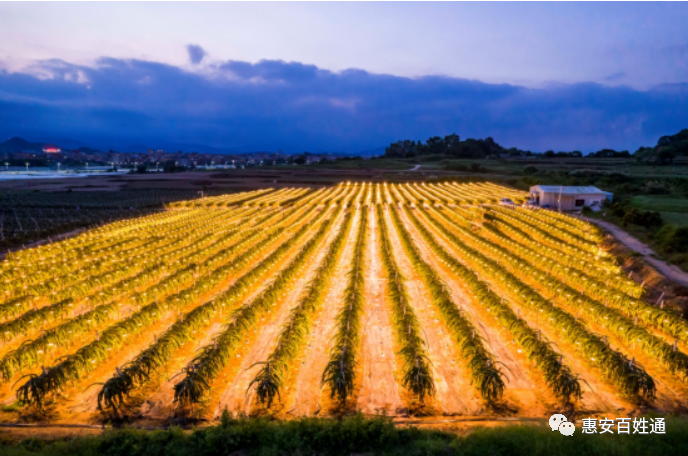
[384, 209, 482, 415]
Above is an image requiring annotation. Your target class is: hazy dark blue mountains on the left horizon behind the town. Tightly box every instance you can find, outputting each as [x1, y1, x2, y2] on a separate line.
[0, 137, 385, 157]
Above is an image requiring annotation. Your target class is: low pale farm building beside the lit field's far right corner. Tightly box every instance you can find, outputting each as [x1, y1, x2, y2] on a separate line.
[530, 185, 613, 211]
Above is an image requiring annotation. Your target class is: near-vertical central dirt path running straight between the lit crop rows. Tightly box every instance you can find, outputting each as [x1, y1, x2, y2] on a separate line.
[357, 211, 404, 415]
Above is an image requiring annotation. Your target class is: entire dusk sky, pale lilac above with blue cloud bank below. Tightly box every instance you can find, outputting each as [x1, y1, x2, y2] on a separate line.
[0, 3, 688, 152]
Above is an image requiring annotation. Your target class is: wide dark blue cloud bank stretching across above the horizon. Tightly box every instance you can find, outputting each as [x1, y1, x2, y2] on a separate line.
[0, 58, 688, 152]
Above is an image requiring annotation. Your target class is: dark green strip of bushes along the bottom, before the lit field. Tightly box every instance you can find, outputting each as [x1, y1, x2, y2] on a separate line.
[0, 415, 688, 456]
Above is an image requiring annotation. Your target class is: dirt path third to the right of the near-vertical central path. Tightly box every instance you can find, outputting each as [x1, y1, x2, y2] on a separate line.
[421, 208, 633, 412]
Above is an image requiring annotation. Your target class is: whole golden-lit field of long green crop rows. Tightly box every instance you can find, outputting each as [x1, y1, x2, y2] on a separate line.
[0, 183, 688, 422]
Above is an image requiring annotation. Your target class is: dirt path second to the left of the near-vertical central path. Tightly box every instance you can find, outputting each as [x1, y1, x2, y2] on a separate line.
[209, 208, 345, 416]
